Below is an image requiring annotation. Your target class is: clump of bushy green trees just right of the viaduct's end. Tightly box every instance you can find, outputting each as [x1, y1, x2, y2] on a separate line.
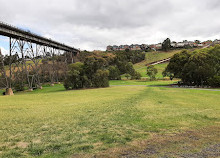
[64, 50, 145, 89]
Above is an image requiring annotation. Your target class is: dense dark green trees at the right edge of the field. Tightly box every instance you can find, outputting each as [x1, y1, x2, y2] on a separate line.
[163, 45, 220, 87]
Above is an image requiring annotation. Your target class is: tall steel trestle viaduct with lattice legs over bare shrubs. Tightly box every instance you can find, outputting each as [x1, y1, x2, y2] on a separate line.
[0, 23, 79, 94]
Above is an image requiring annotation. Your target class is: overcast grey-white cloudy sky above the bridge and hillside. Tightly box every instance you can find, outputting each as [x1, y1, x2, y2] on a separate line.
[0, 0, 220, 52]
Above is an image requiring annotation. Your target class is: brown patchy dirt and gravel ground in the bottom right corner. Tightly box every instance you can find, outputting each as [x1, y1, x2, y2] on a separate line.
[92, 126, 220, 158]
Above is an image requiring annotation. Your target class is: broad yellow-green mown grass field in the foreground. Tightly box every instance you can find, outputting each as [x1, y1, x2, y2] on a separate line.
[0, 81, 220, 158]
